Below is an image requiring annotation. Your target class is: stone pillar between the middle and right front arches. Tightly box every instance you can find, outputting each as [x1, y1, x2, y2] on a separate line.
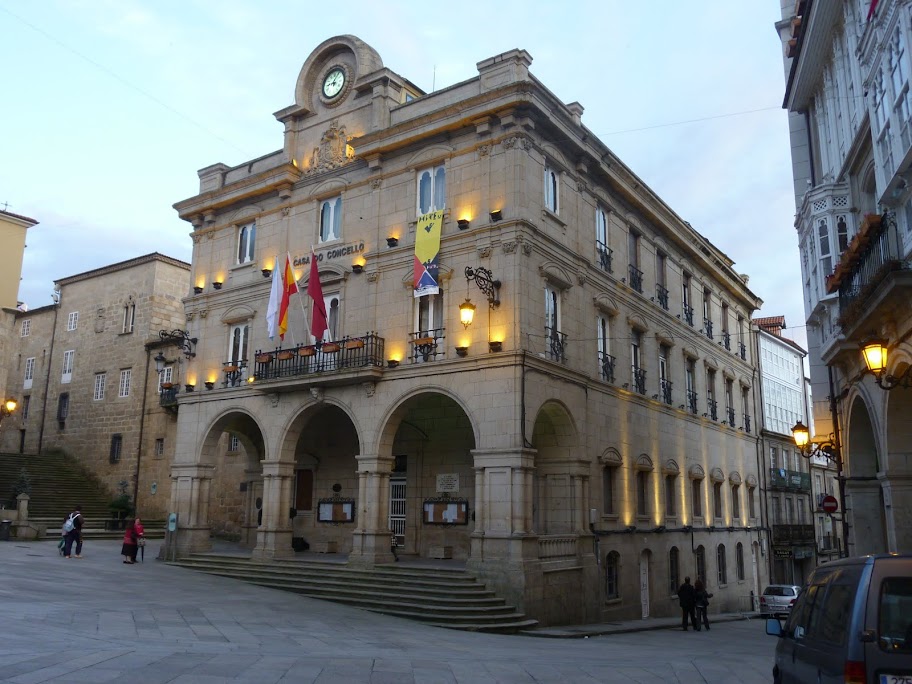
[348, 455, 395, 567]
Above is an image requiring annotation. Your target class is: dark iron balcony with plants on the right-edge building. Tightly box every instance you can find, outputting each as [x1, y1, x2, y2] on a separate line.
[827, 212, 912, 341]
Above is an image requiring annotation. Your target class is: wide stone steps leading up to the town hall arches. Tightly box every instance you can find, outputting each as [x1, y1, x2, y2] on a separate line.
[173, 554, 538, 633]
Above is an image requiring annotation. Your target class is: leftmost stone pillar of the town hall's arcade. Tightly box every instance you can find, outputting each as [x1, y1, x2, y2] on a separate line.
[171, 464, 215, 556]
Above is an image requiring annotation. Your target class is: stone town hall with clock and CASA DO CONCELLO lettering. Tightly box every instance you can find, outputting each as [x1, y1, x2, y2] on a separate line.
[171, 36, 767, 623]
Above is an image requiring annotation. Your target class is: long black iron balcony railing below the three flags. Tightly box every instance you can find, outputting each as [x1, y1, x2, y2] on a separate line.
[254, 333, 384, 381]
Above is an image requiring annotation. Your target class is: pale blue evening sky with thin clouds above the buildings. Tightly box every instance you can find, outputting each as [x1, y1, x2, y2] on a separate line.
[0, 0, 806, 346]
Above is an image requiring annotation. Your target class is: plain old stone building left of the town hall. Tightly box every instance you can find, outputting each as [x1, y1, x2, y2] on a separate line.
[0, 254, 190, 518]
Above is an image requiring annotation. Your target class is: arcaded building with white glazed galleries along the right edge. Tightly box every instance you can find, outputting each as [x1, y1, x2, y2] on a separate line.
[776, 0, 912, 555]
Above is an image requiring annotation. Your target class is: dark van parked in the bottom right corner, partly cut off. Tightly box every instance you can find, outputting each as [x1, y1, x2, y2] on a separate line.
[766, 554, 912, 684]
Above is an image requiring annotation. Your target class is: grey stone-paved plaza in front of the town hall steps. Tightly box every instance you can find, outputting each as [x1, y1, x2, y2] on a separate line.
[0, 541, 776, 684]
